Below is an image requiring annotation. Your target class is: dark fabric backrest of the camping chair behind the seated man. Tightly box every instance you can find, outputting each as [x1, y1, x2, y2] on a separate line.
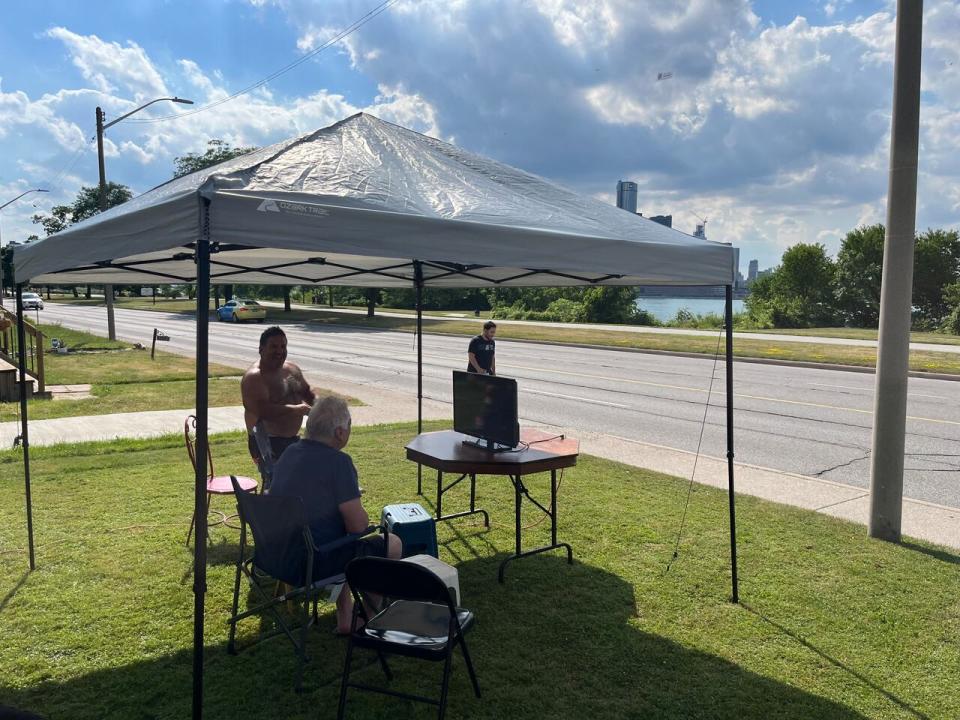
[230, 475, 310, 585]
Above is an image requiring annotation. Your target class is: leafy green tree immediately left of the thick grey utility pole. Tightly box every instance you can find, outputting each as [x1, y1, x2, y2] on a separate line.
[836, 224, 885, 327]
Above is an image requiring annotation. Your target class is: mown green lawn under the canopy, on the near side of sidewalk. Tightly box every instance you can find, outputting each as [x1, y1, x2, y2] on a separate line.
[0, 425, 960, 720]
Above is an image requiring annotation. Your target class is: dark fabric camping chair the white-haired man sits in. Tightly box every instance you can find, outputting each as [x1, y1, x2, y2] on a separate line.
[227, 477, 388, 692]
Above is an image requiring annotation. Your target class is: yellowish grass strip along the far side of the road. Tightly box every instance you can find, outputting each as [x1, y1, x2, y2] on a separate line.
[47, 298, 960, 375]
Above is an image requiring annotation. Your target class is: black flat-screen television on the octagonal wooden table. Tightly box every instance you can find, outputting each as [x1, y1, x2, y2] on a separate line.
[453, 371, 520, 448]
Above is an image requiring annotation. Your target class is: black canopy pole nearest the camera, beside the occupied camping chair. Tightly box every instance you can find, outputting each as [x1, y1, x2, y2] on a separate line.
[191, 199, 210, 720]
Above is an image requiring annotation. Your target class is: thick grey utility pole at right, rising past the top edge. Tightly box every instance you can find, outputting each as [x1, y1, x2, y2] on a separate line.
[869, 0, 923, 542]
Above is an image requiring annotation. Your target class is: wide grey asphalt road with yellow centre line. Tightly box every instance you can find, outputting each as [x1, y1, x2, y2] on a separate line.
[41, 303, 960, 507]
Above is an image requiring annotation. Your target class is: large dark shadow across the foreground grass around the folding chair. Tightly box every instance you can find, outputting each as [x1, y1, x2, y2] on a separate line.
[0, 556, 863, 720]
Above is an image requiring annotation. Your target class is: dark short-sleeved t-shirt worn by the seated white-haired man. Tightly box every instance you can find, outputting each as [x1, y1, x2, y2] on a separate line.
[270, 438, 360, 545]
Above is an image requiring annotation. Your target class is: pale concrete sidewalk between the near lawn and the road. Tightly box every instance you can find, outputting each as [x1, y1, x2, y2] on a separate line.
[0, 376, 960, 549]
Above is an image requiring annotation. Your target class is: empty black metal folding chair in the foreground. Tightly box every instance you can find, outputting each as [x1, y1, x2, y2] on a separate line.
[337, 557, 488, 720]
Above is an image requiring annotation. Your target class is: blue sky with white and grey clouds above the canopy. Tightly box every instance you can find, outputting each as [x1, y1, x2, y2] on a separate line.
[0, 0, 960, 267]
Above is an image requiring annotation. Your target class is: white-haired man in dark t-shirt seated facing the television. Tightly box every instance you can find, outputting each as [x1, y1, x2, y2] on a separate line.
[270, 395, 402, 633]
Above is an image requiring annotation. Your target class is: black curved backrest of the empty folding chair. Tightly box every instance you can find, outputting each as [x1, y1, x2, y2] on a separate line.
[346, 557, 453, 608]
